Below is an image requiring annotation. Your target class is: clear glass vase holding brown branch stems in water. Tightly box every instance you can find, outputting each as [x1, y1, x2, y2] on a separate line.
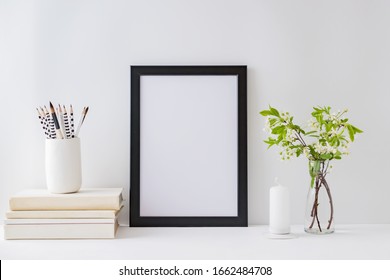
[304, 161, 334, 234]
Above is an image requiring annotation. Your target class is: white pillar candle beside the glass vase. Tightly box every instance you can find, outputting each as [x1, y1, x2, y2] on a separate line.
[269, 182, 290, 234]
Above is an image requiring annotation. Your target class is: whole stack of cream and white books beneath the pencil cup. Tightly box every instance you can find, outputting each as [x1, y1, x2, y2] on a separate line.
[4, 188, 123, 239]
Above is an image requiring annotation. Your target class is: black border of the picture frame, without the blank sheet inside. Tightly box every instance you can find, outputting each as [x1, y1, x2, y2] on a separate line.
[130, 65, 248, 227]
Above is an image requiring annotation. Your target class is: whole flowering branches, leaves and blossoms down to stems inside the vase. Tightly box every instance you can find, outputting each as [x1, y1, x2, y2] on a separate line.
[260, 106, 363, 232]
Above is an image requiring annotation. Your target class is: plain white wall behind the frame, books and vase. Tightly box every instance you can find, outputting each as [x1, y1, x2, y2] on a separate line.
[0, 0, 390, 224]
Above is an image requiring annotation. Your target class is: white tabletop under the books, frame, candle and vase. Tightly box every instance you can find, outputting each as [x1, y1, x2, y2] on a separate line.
[0, 224, 390, 260]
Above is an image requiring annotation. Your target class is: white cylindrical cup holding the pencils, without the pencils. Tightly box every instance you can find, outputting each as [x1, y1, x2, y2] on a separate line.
[45, 137, 81, 193]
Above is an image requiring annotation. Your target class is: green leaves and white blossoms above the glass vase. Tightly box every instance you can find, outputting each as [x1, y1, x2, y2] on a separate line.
[260, 106, 363, 167]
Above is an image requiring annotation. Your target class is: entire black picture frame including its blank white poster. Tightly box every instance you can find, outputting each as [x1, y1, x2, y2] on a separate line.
[130, 66, 247, 226]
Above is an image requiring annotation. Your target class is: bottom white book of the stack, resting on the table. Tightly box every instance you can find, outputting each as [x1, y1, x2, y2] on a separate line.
[4, 222, 118, 239]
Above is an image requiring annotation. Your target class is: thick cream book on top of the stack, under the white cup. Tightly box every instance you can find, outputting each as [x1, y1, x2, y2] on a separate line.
[9, 188, 123, 211]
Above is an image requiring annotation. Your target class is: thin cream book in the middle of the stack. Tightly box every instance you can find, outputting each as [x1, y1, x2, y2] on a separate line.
[5, 205, 120, 219]
